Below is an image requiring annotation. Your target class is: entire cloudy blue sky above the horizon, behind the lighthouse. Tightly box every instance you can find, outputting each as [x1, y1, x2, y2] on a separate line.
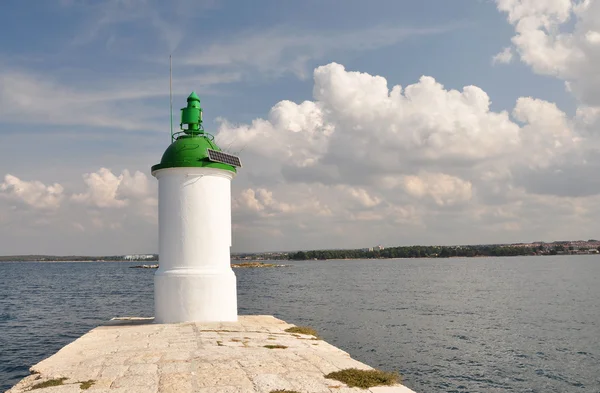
[0, 0, 600, 255]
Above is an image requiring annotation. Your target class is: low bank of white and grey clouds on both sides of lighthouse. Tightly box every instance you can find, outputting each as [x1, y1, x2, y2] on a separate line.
[0, 56, 600, 252]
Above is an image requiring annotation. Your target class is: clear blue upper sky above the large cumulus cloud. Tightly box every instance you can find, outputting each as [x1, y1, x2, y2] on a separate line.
[0, 0, 573, 122]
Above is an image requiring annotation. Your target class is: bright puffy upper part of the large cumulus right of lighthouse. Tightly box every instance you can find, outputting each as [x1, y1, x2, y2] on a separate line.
[218, 63, 578, 184]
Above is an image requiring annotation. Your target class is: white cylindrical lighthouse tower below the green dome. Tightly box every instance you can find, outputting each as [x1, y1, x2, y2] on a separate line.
[152, 168, 237, 323]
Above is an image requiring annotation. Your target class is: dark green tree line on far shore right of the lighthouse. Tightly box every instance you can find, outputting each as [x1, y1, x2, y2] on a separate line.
[288, 245, 538, 261]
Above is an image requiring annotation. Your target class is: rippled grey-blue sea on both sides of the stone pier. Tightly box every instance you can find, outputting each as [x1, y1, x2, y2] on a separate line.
[0, 255, 600, 393]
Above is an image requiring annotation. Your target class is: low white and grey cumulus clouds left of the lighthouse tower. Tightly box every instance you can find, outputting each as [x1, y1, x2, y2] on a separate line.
[0, 168, 158, 255]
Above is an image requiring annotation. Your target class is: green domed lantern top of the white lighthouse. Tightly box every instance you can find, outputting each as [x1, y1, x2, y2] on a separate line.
[152, 92, 241, 172]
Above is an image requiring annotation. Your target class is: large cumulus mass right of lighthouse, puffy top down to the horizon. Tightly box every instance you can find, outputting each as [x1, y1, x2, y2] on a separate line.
[218, 63, 600, 248]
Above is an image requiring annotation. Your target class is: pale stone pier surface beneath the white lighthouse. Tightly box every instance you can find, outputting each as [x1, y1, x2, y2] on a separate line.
[8, 316, 414, 393]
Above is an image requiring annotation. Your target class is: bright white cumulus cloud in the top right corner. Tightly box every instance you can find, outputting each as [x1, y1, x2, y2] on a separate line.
[496, 0, 600, 106]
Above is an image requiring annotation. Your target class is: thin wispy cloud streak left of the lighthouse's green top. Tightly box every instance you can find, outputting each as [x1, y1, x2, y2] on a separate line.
[0, 71, 241, 131]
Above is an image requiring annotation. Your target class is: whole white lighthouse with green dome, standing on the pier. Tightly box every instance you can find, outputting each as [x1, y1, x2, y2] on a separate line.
[152, 92, 241, 323]
